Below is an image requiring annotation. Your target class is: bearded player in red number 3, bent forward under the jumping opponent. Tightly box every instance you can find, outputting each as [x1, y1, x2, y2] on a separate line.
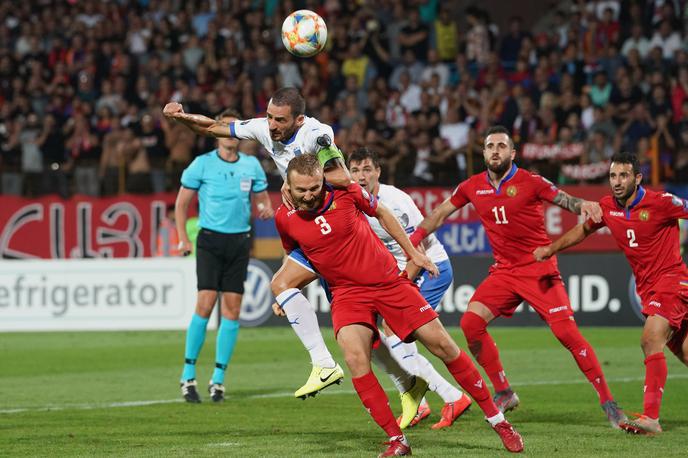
[275, 154, 523, 456]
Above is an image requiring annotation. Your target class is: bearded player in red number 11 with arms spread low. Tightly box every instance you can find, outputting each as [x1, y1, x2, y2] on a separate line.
[411, 126, 626, 428]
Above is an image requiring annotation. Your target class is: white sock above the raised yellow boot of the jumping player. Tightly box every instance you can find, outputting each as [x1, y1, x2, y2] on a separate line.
[275, 288, 336, 368]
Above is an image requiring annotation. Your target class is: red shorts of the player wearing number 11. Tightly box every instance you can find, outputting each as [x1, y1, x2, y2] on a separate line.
[471, 269, 573, 323]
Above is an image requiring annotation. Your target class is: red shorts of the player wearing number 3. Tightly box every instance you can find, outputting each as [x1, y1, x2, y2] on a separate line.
[331, 277, 437, 340]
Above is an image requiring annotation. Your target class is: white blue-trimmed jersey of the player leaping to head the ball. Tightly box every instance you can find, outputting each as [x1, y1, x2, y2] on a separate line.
[229, 116, 334, 179]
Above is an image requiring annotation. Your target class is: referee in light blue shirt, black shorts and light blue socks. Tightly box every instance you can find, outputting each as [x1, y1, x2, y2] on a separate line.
[175, 110, 274, 402]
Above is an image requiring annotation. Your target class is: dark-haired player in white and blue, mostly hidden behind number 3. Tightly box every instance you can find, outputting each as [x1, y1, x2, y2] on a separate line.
[349, 148, 471, 429]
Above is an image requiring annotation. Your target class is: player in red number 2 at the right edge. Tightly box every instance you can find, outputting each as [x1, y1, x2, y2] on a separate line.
[534, 153, 688, 434]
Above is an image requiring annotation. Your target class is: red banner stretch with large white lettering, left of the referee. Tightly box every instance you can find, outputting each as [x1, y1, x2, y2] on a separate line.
[0, 193, 176, 259]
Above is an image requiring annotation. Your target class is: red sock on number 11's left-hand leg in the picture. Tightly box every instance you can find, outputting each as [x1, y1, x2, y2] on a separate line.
[461, 312, 509, 392]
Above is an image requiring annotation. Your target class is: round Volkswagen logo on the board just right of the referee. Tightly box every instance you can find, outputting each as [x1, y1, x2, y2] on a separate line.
[239, 259, 273, 327]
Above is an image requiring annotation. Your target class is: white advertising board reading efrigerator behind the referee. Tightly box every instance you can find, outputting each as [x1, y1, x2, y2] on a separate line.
[0, 258, 199, 331]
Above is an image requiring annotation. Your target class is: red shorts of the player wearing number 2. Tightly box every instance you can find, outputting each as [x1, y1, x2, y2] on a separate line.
[640, 276, 688, 330]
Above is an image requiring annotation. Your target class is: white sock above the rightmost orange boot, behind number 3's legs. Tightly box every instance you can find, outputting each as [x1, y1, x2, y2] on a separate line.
[383, 335, 463, 403]
